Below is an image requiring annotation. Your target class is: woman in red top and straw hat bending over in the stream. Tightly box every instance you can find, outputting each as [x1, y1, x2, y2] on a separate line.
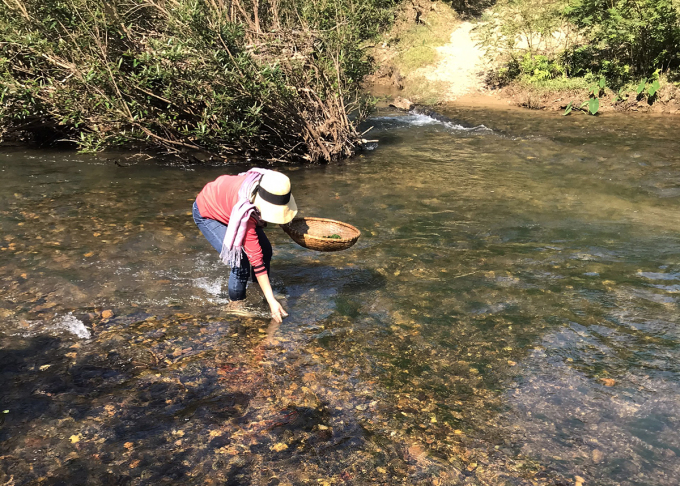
[193, 168, 297, 323]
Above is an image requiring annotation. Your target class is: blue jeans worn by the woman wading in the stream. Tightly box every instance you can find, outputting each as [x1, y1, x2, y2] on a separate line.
[193, 203, 273, 300]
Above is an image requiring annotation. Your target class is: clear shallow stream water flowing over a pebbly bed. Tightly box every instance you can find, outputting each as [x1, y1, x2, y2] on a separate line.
[0, 108, 680, 485]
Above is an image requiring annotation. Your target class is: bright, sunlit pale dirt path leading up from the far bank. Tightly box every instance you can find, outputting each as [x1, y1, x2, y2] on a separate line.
[415, 22, 484, 101]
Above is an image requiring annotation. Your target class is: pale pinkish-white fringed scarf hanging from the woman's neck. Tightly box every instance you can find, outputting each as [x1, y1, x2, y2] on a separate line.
[220, 168, 268, 268]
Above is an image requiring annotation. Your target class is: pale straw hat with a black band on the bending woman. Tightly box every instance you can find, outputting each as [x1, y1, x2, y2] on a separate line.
[253, 170, 297, 224]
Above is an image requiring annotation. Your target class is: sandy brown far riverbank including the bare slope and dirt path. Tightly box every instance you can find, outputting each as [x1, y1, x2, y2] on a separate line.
[365, 2, 680, 114]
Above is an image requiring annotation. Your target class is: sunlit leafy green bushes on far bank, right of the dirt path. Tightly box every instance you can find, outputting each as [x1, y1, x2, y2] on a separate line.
[477, 0, 680, 87]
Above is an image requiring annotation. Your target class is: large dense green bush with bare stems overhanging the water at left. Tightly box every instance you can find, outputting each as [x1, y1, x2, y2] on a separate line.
[0, 0, 391, 162]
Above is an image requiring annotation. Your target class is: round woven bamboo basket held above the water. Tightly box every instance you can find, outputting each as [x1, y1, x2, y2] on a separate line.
[281, 218, 361, 251]
